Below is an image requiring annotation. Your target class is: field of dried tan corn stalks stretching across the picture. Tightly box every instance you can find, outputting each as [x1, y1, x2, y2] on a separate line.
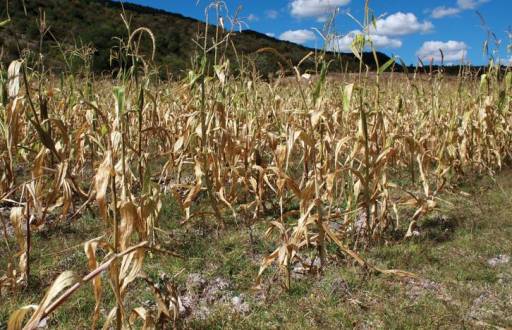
[0, 1, 512, 330]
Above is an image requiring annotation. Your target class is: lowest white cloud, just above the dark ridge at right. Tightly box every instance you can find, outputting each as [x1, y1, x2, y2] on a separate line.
[416, 40, 468, 62]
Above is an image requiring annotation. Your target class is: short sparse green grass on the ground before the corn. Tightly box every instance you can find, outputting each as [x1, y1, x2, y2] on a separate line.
[0, 171, 512, 329]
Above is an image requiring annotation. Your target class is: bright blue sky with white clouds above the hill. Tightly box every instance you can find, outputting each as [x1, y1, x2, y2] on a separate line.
[122, 0, 512, 64]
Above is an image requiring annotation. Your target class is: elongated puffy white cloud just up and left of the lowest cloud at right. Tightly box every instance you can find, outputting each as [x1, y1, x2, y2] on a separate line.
[371, 12, 434, 36]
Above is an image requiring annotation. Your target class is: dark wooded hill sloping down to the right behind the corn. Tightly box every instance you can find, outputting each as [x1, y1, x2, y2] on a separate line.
[0, 0, 389, 74]
